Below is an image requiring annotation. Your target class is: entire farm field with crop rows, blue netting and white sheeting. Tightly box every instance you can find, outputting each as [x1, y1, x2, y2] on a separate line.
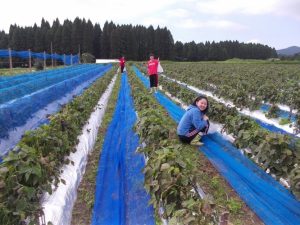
[0, 62, 300, 225]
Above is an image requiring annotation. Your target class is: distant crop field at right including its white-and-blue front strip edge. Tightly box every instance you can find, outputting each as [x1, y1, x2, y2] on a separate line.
[157, 63, 300, 135]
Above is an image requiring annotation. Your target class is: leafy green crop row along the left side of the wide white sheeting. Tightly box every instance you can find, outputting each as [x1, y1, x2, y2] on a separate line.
[0, 67, 113, 225]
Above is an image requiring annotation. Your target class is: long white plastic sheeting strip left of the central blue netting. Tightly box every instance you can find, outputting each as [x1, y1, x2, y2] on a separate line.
[41, 75, 117, 225]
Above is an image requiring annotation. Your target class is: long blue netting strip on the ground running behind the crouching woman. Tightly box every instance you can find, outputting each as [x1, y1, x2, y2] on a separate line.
[135, 68, 300, 225]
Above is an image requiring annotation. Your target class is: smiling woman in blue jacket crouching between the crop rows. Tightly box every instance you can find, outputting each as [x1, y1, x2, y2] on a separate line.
[177, 96, 209, 146]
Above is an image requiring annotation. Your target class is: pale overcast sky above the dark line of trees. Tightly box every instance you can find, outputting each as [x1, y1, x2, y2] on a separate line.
[0, 0, 300, 49]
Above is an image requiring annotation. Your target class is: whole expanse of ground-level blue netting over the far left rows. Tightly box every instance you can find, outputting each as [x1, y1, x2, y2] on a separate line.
[0, 65, 112, 156]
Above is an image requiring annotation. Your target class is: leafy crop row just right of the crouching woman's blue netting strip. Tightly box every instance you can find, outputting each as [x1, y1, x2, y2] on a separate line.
[154, 70, 300, 198]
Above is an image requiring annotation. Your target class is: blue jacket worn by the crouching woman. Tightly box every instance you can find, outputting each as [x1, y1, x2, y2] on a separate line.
[177, 105, 207, 136]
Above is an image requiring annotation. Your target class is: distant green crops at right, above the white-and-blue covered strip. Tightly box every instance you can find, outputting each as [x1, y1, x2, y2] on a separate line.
[163, 60, 300, 118]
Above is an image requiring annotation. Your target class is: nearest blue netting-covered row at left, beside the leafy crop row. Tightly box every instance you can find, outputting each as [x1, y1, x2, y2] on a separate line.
[0, 65, 111, 156]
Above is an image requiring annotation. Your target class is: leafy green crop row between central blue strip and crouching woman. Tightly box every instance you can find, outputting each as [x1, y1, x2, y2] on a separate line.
[129, 65, 260, 224]
